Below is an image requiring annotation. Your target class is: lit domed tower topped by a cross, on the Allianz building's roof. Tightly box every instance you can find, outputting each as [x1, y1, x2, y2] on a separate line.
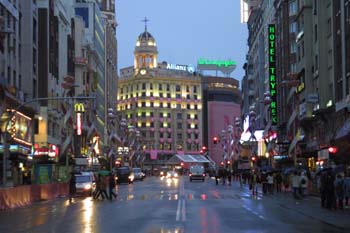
[134, 17, 158, 71]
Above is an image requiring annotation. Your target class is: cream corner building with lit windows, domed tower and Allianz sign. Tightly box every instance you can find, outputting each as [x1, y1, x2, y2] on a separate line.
[117, 27, 202, 165]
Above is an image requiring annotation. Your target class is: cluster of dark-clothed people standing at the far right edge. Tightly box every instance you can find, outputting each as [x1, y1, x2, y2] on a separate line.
[319, 171, 350, 209]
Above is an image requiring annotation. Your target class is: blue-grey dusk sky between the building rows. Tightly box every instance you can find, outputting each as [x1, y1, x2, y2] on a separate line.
[116, 0, 248, 83]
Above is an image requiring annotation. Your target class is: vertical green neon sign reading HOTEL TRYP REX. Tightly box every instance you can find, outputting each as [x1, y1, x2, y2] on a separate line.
[268, 24, 277, 125]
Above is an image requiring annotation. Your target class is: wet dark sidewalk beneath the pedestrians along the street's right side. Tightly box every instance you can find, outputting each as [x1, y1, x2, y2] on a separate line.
[234, 181, 350, 229]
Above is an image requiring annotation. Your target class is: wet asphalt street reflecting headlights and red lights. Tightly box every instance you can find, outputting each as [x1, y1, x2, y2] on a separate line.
[0, 177, 350, 233]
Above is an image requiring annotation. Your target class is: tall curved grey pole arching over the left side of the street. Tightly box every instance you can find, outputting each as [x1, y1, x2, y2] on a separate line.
[2, 96, 95, 187]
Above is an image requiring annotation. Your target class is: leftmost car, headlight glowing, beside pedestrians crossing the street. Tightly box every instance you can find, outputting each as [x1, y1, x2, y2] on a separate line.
[75, 172, 96, 196]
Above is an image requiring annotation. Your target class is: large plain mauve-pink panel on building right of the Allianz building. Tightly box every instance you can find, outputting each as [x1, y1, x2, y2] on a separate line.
[208, 101, 241, 164]
